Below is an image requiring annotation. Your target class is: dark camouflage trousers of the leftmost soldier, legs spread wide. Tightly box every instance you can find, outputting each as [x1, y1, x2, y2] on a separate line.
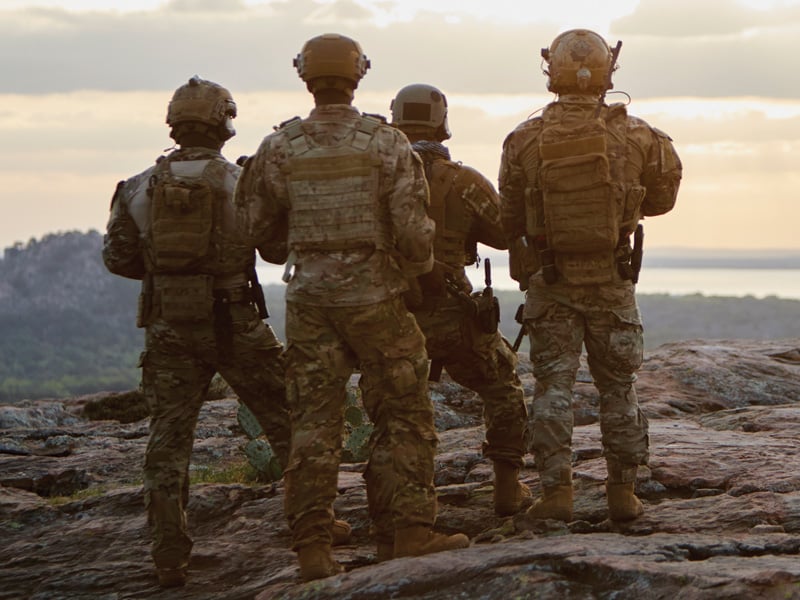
[140, 303, 290, 568]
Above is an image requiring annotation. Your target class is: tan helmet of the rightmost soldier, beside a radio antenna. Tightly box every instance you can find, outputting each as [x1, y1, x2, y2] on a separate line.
[542, 29, 613, 94]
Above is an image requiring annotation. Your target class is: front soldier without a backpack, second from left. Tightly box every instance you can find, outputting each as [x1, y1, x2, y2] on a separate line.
[235, 34, 469, 580]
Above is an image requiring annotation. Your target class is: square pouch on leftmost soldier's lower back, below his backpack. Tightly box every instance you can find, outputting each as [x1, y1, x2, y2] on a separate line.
[154, 275, 214, 323]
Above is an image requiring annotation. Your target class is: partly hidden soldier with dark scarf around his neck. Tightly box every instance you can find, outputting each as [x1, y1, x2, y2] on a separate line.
[391, 83, 531, 516]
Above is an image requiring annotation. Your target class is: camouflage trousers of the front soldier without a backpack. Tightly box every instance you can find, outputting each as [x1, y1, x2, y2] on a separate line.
[284, 298, 437, 550]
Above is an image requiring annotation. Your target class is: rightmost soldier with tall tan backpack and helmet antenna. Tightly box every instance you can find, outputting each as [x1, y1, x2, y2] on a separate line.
[499, 29, 681, 521]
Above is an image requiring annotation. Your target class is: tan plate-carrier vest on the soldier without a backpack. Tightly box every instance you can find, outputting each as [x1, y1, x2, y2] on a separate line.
[282, 115, 392, 252]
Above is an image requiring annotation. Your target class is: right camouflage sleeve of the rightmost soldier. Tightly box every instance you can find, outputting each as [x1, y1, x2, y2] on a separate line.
[641, 128, 683, 217]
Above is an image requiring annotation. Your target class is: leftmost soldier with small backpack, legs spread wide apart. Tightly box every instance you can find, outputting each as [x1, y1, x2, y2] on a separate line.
[103, 76, 349, 587]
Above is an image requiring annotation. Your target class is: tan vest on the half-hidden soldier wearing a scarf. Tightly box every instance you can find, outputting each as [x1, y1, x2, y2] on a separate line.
[425, 160, 477, 268]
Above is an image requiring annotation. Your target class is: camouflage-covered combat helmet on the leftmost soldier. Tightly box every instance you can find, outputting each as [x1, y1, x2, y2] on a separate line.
[167, 75, 236, 141]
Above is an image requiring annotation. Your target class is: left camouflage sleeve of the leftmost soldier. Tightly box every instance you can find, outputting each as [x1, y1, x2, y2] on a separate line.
[103, 181, 145, 279]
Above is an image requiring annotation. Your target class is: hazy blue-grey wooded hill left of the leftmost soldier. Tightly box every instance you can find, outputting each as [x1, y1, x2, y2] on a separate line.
[0, 231, 144, 402]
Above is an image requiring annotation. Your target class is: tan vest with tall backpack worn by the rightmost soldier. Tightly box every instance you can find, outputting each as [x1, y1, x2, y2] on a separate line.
[526, 103, 643, 284]
